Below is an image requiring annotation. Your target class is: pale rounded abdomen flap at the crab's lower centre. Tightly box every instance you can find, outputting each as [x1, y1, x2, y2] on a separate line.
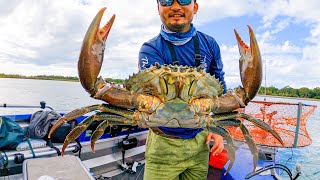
[147, 98, 202, 128]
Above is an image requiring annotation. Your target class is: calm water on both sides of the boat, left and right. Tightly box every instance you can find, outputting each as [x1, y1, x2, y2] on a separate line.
[0, 78, 320, 180]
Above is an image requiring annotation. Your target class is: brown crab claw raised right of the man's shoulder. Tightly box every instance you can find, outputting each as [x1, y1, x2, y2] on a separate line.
[234, 25, 262, 104]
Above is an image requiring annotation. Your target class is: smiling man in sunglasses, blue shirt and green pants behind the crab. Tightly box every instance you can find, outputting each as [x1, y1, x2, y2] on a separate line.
[139, 0, 226, 180]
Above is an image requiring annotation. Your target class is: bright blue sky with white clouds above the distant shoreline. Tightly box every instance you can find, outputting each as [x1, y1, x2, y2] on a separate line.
[0, 0, 320, 89]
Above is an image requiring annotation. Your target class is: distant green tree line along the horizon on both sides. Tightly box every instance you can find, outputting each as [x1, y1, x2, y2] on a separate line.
[0, 73, 320, 99]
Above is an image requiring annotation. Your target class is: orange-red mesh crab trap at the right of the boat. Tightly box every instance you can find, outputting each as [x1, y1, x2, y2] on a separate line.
[227, 101, 317, 148]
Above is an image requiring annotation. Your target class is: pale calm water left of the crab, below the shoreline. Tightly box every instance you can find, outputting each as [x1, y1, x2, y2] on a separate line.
[0, 78, 102, 115]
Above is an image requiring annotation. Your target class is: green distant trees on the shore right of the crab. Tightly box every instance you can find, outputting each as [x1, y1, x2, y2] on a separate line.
[259, 86, 320, 99]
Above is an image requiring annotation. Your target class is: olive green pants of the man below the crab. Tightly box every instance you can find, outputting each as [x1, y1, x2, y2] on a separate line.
[144, 130, 209, 180]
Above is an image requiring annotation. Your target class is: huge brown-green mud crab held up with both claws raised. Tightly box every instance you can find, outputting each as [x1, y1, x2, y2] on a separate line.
[49, 8, 283, 173]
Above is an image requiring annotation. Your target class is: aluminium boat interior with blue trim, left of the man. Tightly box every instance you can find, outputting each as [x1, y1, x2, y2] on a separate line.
[0, 102, 148, 180]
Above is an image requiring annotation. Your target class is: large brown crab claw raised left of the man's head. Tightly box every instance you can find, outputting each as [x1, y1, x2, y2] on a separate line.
[78, 7, 115, 96]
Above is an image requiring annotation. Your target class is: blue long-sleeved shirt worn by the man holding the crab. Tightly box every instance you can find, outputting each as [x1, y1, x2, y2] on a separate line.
[139, 31, 227, 139]
